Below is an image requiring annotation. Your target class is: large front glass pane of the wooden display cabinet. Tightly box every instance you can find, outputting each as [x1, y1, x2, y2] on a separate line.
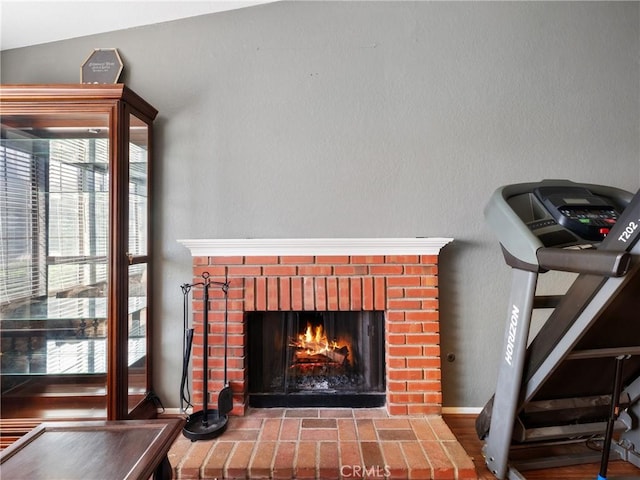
[0, 111, 110, 417]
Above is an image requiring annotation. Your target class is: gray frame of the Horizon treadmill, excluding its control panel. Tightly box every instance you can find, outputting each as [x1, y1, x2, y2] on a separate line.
[483, 180, 640, 480]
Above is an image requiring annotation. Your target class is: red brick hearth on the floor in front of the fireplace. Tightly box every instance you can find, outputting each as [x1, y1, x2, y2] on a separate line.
[169, 408, 478, 480]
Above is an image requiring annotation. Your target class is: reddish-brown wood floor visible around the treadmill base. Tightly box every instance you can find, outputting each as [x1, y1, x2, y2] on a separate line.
[443, 414, 640, 480]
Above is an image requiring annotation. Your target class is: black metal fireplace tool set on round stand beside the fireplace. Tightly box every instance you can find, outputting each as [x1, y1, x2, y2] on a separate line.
[180, 272, 233, 442]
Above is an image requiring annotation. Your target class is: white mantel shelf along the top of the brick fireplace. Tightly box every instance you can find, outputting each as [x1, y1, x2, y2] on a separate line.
[178, 237, 453, 257]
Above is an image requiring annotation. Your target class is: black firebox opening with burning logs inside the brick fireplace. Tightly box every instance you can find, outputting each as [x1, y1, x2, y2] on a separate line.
[246, 311, 385, 408]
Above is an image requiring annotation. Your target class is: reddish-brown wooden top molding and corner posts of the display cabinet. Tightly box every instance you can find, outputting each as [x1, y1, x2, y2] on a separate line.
[0, 84, 158, 420]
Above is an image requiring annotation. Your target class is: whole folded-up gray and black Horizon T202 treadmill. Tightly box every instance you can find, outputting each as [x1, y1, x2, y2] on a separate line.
[476, 180, 640, 480]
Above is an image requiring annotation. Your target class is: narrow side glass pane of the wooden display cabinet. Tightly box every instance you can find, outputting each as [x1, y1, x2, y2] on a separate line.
[127, 115, 149, 412]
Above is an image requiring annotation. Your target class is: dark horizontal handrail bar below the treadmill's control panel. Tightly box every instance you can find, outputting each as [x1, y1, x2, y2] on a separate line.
[536, 247, 631, 277]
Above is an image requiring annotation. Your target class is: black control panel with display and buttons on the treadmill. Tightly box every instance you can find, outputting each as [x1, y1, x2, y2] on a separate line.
[533, 186, 619, 241]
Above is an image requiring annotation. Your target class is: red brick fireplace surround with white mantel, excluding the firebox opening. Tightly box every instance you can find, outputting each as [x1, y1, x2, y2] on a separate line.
[180, 238, 452, 415]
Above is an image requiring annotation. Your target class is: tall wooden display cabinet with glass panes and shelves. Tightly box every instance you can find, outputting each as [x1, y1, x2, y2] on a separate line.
[0, 84, 157, 420]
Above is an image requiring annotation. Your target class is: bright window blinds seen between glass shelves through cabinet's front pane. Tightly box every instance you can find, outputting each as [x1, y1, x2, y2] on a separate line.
[0, 138, 109, 304]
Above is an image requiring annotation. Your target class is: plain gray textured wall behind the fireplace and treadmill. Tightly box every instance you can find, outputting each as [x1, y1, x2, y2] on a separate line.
[1, 2, 640, 407]
